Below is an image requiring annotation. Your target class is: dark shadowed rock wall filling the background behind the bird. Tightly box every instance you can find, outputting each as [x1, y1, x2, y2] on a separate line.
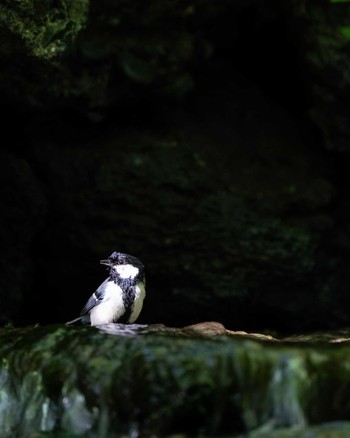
[0, 0, 350, 333]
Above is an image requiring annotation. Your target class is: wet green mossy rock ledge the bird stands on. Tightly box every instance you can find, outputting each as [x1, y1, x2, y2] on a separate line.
[0, 322, 350, 437]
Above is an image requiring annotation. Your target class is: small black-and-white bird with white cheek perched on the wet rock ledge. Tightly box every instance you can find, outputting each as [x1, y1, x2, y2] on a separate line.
[67, 252, 146, 325]
